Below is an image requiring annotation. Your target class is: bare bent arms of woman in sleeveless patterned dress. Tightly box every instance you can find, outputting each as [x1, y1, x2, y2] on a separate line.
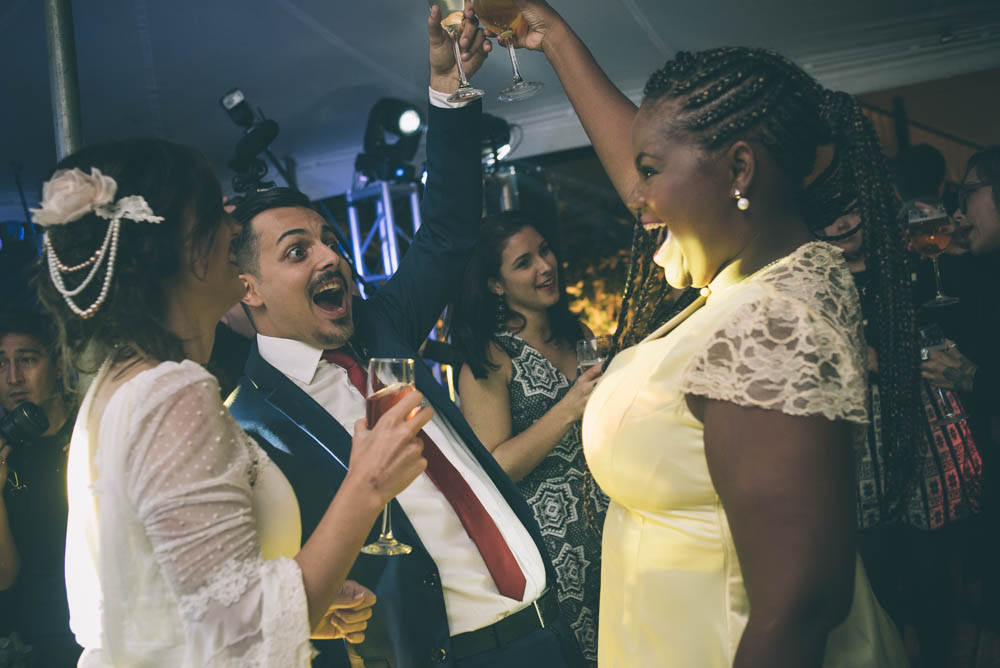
[458, 344, 601, 482]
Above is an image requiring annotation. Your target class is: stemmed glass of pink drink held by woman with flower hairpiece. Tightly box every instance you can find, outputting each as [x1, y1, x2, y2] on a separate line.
[361, 357, 414, 557]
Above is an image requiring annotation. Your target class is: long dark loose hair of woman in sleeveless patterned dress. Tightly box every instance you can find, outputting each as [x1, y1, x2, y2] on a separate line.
[448, 212, 582, 378]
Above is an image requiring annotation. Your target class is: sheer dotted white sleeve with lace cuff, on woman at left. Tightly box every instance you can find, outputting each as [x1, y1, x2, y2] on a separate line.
[125, 372, 312, 666]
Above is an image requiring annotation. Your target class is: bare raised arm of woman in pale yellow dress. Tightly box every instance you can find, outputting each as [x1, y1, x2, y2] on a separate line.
[516, 0, 637, 201]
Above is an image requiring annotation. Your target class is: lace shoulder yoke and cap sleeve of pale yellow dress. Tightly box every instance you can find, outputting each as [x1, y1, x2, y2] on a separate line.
[681, 242, 868, 423]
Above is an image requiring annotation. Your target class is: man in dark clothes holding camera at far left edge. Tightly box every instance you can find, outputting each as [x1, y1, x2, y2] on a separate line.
[0, 311, 80, 666]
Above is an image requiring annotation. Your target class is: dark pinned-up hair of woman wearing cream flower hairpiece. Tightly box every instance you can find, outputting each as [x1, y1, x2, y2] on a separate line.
[35, 139, 224, 380]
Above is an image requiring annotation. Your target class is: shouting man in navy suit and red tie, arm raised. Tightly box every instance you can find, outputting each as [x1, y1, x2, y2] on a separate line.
[230, 12, 583, 668]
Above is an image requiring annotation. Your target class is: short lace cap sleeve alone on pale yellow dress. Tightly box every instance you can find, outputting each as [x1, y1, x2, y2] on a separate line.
[681, 293, 868, 423]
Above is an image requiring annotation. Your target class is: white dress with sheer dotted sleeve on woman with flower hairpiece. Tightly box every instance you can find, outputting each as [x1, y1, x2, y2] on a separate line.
[66, 361, 311, 666]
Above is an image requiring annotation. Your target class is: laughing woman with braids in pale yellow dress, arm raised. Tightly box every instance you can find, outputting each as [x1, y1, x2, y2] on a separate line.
[504, 0, 917, 668]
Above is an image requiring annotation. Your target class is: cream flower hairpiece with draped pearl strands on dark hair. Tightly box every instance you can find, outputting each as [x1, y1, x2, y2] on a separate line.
[31, 167, 163, 319]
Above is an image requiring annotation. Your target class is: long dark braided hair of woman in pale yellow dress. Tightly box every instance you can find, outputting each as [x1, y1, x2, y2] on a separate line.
[615, 47, 920, 515]
